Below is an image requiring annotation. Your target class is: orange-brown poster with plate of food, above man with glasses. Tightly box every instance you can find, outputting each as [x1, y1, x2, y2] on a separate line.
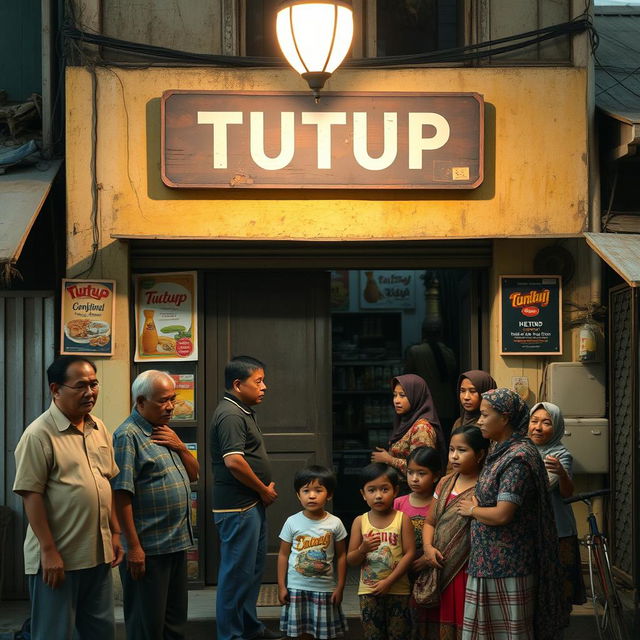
[60, 278, 116, 356]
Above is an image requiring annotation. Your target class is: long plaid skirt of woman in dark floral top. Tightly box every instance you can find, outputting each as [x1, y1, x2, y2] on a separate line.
[462, 575, 536, 640]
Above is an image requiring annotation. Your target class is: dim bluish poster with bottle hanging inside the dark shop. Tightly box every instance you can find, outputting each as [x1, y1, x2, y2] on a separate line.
[360, 271, 416, 309]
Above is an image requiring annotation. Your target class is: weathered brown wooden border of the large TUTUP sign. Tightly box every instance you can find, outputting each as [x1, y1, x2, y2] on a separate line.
[160, 89, 485, 191]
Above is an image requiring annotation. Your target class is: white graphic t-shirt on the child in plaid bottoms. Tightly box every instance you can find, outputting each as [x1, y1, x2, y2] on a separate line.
[280, 511, 347, 591]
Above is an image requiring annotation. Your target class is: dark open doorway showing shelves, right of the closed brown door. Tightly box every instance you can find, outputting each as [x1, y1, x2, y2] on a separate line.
[330, 269, 481, 526]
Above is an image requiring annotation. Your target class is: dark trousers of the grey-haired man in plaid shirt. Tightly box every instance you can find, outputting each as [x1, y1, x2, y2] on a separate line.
[120, 551, 188, 640]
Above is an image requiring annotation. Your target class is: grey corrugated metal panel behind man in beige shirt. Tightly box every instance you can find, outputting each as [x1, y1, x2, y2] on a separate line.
[0, 291, 55, 598]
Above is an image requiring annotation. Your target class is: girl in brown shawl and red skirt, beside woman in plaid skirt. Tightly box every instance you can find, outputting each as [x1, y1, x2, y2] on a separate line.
[412, 425, 490, 640]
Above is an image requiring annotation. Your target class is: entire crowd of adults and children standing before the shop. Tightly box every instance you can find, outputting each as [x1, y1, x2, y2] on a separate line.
[13, 356, 585, 640]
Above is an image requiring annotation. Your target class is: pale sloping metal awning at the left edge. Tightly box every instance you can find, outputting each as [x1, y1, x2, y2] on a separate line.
[0, 160, 62, 263]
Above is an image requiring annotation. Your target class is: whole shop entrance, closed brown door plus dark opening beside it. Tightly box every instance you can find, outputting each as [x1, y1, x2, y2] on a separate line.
[204, 269, 479, 583]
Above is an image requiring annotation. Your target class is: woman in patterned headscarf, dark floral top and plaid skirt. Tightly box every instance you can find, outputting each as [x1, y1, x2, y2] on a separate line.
[458, 389, 566, 640]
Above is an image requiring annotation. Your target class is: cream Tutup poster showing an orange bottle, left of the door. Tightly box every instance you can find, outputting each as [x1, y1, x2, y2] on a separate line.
[135, 271, 198, 362]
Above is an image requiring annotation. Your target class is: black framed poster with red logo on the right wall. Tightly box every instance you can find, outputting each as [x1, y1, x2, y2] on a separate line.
[499, 274, 563, 356]
